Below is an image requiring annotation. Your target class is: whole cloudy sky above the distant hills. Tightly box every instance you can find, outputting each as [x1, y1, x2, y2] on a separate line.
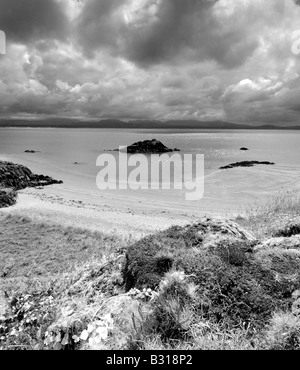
[0, 0, 300, 125]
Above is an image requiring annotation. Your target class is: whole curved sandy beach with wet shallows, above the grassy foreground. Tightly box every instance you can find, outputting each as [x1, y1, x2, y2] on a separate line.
[1, 150, 300, 238]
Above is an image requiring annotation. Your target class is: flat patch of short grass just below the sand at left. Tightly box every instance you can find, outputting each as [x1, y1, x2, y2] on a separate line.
[0, 214, 126, 278]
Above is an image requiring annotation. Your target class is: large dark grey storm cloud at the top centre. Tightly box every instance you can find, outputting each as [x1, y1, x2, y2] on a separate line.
[78, 0, 258, 68]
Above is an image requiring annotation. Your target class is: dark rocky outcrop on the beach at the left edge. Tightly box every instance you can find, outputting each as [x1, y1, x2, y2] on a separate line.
[0, 161, 62, 208]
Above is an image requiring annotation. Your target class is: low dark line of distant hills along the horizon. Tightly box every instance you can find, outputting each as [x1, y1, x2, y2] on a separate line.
[0, 118, 300, 130]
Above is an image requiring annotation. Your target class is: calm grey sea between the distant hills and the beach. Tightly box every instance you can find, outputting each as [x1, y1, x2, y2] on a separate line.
[0, 128, 300, 212]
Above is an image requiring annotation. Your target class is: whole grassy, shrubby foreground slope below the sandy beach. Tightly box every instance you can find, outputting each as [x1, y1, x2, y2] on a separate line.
[0, 192, 300, 350]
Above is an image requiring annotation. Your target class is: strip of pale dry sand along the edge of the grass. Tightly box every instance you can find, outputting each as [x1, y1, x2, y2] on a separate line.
[1, 189, 196, 238]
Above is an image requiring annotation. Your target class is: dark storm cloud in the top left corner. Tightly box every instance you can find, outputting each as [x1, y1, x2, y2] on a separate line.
[0, 0, 68, 43]
